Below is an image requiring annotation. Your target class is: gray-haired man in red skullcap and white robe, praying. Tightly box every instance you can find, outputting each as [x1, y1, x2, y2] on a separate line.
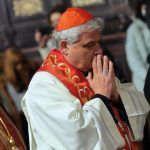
[22, 8, 150, 150]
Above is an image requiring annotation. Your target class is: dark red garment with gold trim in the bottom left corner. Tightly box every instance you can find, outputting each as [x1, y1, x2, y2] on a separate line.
[0, 106, 26, 150]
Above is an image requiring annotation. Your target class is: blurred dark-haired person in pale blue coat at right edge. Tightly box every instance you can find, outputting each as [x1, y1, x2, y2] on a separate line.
[126, 0, 150, 92]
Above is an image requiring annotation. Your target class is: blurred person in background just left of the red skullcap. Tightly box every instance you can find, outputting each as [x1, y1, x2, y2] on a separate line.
[35, 4, 66, 59]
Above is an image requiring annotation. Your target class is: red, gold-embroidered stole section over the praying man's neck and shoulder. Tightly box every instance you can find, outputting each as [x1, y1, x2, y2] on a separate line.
[38, 50, 94, 105]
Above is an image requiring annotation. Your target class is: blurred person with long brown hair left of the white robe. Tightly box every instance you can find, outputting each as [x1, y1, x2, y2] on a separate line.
[4, 47, 37, 149]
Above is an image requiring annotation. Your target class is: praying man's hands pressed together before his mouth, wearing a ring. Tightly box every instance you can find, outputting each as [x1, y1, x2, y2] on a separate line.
[87, 55, 119, 101]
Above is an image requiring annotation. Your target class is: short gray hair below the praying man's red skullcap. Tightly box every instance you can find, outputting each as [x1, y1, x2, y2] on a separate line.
[53, 18, 104, 47]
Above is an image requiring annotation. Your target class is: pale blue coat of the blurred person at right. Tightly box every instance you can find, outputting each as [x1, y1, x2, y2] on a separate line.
[126, 19, 150, 92]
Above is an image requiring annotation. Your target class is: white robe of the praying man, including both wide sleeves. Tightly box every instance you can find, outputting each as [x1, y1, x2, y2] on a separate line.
[22, 72, 149, 150]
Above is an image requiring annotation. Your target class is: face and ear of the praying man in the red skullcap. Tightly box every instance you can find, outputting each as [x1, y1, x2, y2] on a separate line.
[61, 31, 103, 72]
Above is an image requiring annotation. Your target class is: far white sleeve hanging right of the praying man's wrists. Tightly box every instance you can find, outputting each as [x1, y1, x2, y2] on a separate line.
[117, 78, 150, 140]
